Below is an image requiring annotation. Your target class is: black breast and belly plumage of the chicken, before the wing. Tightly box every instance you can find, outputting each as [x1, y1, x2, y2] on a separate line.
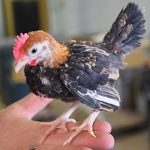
[24, 63, 76, 102]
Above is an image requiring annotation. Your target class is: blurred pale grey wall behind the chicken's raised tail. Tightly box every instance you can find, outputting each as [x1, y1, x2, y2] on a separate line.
[47, 0, 150, 37]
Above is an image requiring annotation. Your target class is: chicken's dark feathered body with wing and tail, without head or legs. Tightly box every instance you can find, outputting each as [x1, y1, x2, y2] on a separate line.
[25, 3, 145, 111]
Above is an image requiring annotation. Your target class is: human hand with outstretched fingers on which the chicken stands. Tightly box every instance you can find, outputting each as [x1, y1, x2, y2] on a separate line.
[0, 93, 114, 150]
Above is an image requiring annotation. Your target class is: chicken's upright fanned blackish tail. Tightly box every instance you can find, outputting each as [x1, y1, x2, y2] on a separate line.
[101, 3, 145, 55]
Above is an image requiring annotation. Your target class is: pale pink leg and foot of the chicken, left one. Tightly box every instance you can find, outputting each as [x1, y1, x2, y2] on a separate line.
[40, 101, 81, 144]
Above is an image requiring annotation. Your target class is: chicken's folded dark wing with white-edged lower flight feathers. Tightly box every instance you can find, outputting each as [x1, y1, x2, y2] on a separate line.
[60, 44, 120, 111]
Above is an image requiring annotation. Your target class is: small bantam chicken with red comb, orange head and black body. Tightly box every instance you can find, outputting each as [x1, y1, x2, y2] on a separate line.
[13, 3, 145, 145]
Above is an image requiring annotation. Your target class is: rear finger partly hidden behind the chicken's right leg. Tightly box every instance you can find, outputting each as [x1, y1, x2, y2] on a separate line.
[67, 121, 112, 133]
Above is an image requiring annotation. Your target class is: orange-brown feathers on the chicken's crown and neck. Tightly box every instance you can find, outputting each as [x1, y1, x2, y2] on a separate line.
[23, 30, 69, 68]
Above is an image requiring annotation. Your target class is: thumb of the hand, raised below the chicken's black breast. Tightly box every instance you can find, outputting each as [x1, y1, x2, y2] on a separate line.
[8, 93, 52, 119]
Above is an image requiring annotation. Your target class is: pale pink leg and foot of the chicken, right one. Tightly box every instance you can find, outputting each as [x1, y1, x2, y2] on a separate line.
[63, 110, 100, 145]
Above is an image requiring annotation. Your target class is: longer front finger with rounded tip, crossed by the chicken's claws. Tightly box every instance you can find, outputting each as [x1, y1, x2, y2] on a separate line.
[45, 131, 114, 149]
